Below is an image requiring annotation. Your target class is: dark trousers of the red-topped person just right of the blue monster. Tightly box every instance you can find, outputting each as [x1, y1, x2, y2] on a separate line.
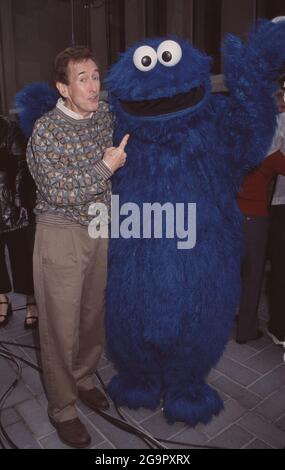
[237, 216, 269, 341]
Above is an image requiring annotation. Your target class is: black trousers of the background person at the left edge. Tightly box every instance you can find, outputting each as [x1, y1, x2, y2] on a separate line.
[0, 225, 35, 295]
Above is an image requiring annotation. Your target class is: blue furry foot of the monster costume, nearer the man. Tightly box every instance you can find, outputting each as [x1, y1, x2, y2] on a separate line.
[107, 374, 160, 410]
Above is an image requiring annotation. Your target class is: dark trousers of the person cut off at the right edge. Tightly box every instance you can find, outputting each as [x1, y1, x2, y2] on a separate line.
[268, 204, 285, 341]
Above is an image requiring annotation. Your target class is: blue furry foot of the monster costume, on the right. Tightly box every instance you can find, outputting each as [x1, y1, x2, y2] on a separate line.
[164, 384, 224, 426]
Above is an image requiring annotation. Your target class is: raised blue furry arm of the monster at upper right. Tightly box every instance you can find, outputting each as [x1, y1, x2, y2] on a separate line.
[220, 20, 285, 178]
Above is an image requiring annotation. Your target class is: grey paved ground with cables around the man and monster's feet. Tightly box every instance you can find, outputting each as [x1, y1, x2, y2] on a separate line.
[0, 288, 285, 449]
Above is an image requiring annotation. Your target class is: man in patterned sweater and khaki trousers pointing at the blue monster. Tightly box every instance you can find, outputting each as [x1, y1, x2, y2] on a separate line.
[27, 46, 129, 448]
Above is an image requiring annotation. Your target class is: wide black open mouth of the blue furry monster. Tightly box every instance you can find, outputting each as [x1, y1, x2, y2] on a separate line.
[121, 86, 205, 116]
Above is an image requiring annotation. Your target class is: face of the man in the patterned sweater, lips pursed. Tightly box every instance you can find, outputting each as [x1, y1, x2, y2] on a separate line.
[56, 59, 100, 117]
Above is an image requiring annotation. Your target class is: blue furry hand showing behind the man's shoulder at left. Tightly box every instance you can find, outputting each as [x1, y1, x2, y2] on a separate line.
[15, 82, 59, 138]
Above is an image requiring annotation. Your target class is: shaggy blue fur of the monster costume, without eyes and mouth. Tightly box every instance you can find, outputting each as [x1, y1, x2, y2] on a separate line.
[106, 21, 285, 426]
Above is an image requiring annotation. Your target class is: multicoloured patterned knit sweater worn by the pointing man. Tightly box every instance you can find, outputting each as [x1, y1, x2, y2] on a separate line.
[27, 102, 112, 225]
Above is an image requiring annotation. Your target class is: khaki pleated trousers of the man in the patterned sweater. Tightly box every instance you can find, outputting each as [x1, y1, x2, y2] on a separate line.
[34, 223, 108, 422]
